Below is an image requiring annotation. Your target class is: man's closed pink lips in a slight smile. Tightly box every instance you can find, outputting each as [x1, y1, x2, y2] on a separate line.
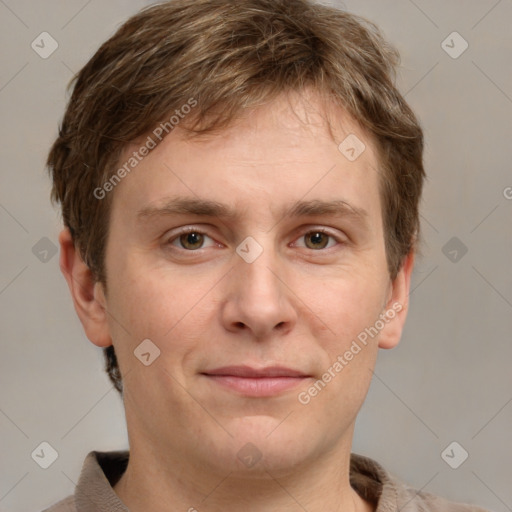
[202, 366, 311, 397]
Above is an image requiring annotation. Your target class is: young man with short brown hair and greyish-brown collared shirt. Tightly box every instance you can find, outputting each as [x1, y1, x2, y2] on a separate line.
[43, 0, 488, 512]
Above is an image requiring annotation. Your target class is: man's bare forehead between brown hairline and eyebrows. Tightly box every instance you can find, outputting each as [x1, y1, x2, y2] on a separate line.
[110, 90, 380, 228]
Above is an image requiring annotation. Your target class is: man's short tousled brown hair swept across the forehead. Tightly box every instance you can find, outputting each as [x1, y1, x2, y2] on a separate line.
[47, 0, 425, 392]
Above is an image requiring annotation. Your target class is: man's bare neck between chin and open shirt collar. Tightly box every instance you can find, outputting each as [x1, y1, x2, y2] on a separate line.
[114, 443, 374, 512]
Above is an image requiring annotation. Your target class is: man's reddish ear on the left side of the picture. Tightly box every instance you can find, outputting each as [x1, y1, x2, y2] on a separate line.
[59, 228, 112, 347]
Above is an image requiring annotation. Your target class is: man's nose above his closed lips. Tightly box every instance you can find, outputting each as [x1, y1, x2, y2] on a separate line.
[222, 250, 298, 340]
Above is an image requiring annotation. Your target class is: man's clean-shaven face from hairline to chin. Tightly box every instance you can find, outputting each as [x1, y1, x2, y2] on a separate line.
[85, 91, 412, 474]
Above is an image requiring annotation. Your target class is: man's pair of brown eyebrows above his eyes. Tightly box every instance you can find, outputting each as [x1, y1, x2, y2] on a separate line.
[137, 197, 368, 227]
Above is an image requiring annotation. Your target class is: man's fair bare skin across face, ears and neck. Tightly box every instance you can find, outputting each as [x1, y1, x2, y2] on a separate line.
[60, 93, 414, 512]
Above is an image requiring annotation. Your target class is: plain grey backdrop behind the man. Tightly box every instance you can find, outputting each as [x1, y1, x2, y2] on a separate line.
[0, 0, 512, 512]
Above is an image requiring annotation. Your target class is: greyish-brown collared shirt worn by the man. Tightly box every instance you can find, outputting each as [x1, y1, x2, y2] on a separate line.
[43, 451, 488, 512]
